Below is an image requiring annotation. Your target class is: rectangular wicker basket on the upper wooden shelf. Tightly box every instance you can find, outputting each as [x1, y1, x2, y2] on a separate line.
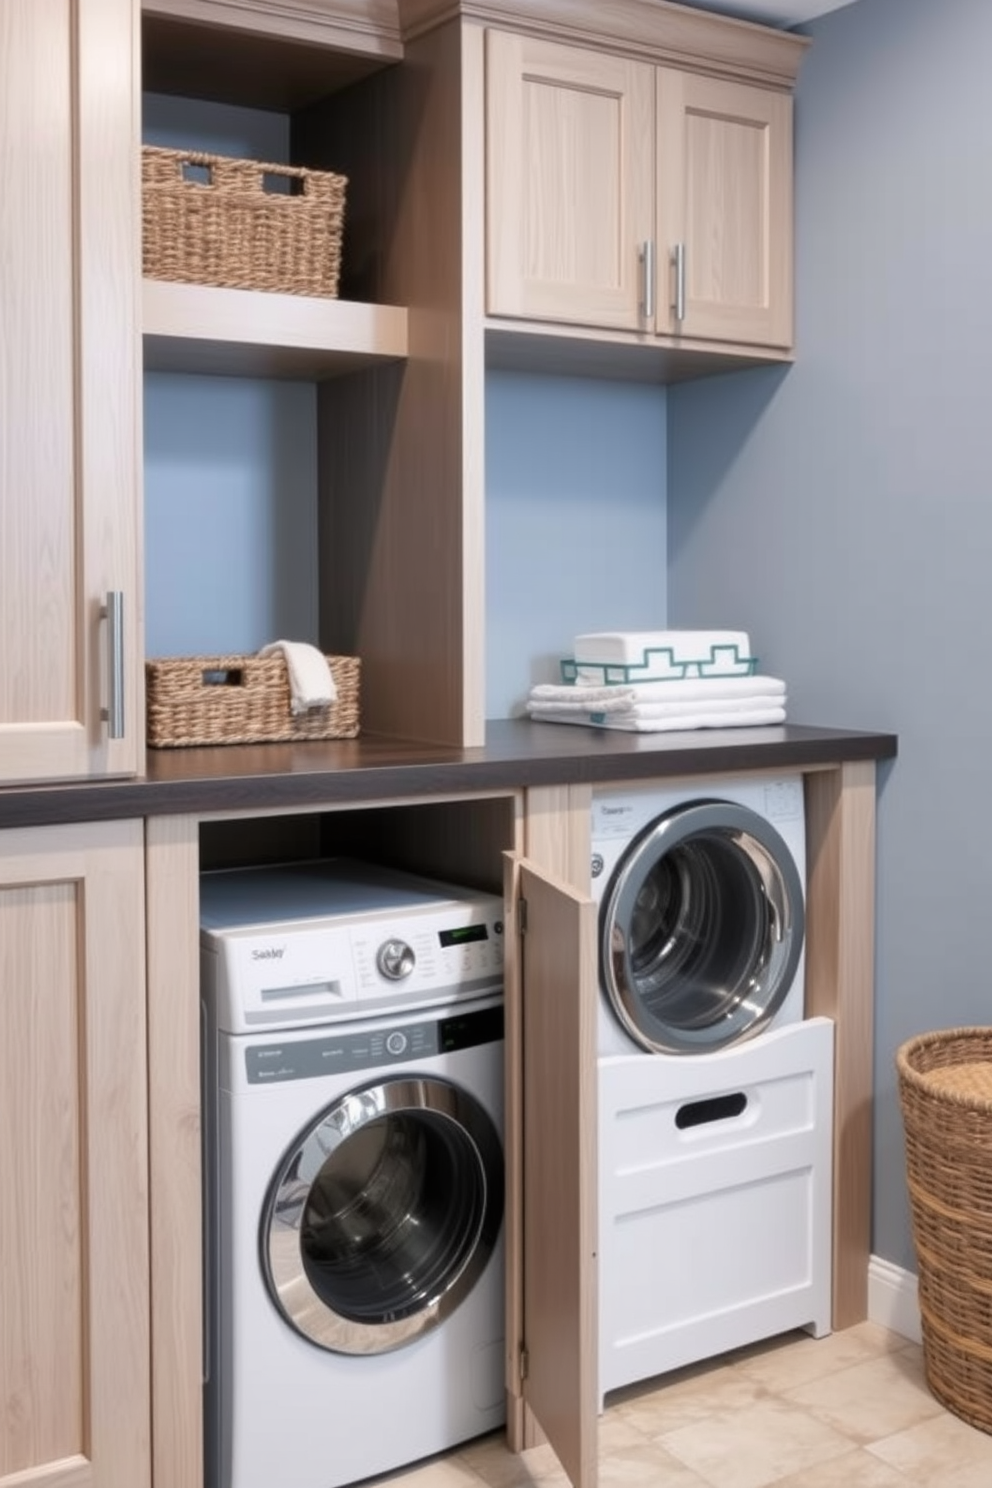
[141, 146, 348, 299]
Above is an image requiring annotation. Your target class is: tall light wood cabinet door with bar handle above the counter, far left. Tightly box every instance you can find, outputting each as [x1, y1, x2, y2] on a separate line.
[0, 0, 143, 783]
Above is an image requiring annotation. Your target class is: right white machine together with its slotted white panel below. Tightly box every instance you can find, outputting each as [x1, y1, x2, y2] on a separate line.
[592, 775, 833, 1399]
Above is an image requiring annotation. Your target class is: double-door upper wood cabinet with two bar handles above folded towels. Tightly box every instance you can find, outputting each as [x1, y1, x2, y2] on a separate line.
[485, 30, 793, 354]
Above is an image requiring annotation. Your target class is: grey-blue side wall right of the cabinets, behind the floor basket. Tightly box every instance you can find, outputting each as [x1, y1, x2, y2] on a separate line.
[669, 0, 992, 1268]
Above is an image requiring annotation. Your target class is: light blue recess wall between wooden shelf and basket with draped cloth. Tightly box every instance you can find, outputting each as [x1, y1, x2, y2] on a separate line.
[144, 372, 318, 656]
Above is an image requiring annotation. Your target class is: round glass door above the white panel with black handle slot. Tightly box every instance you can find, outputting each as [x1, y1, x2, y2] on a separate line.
[601, 801, 805, 1054]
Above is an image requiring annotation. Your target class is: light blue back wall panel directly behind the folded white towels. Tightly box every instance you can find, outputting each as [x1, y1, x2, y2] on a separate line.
[486, 371, 668, 719]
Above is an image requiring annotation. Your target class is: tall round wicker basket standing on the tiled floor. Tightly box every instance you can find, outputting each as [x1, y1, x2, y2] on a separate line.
[895, 1028, 992, 1431]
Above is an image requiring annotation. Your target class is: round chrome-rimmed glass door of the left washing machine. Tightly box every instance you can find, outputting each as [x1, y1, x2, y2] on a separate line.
[262, 1077, 503, 1354]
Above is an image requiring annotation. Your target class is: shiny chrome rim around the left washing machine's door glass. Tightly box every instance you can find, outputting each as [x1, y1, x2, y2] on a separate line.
[260, 1076, 503, 1354]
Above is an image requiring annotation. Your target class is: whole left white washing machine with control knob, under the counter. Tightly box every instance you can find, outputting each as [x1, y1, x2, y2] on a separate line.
[201, 860, 506, 1488]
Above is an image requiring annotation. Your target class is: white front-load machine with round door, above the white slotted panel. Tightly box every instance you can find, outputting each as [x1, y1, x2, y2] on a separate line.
[592, 777, 806, 1055]
